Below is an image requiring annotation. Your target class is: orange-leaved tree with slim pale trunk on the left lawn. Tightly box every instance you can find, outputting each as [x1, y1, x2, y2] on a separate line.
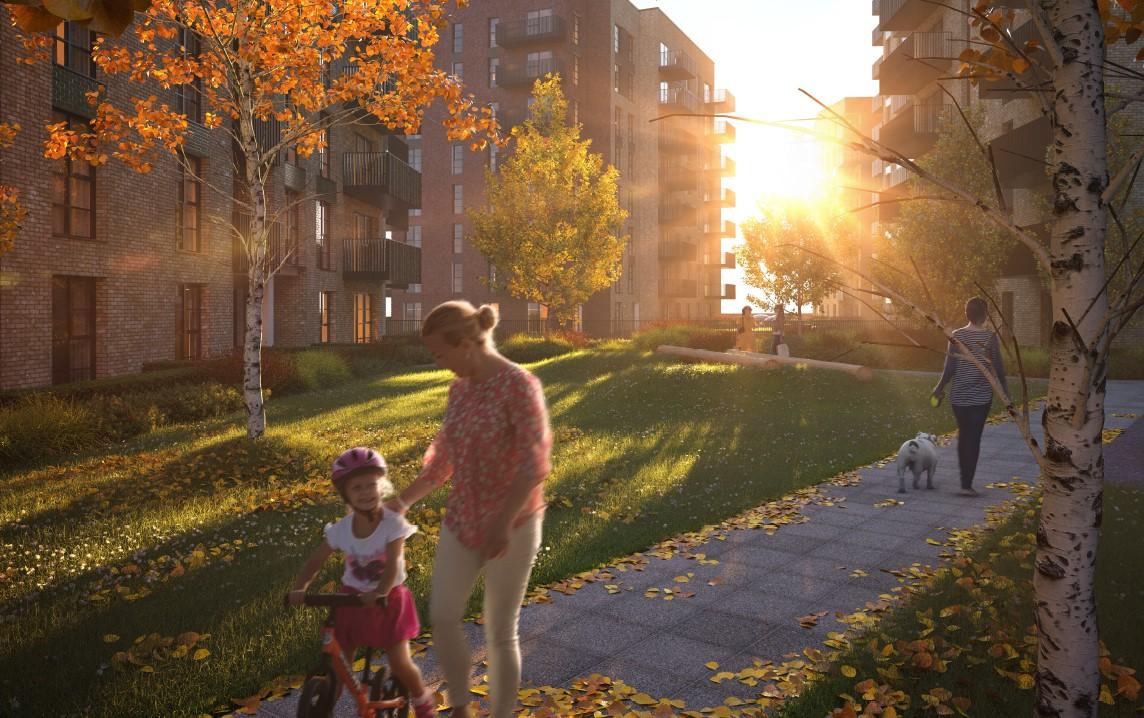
[17, 0, 495, 437]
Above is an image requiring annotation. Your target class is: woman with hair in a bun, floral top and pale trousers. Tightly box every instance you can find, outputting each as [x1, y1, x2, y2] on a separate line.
[390, 302, 553, 718]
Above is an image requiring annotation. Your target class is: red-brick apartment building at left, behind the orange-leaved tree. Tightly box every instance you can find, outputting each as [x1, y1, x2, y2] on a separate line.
[0, 23, 421, 389]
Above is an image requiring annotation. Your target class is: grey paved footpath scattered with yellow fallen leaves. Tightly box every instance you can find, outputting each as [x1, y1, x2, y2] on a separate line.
[260, 381, 1144, 717]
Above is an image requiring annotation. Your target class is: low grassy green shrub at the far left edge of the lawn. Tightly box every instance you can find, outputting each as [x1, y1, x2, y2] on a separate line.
[0, 394, 101, 464]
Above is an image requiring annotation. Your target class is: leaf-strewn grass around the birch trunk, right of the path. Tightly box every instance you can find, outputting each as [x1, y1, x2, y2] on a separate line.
[779, 485, 1144, 718]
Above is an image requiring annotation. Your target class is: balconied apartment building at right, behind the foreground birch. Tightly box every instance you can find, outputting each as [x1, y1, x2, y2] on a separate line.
[872, 0, 1144, 344]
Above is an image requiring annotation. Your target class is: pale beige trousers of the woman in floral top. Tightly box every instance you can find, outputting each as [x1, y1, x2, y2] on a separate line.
[429, 513, 543, 718]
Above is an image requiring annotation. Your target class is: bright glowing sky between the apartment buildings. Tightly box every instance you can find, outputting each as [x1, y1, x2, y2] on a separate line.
[634, 0, 881, 313]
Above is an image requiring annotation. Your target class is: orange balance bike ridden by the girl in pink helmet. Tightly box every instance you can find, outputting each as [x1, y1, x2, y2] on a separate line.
[290, 593, 410, 718]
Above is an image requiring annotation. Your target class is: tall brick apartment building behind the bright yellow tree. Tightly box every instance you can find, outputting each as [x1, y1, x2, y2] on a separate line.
[394, 0, 734, 335]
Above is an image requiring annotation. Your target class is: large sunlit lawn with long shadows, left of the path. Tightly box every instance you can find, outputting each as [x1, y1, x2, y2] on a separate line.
[0, 350, 1011, 717]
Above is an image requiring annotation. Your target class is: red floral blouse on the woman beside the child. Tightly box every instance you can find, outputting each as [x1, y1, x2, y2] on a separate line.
[421, 365, 553, 549]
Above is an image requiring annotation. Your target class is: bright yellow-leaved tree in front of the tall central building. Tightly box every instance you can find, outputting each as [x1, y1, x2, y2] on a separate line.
[469, 75, 628, 324]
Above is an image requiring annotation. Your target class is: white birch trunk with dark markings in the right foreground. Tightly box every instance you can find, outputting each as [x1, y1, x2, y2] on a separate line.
[1033, 0, 1109, 718]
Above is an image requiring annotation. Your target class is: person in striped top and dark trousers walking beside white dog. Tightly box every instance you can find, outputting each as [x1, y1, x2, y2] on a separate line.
[934, 296, 1009, 496]
